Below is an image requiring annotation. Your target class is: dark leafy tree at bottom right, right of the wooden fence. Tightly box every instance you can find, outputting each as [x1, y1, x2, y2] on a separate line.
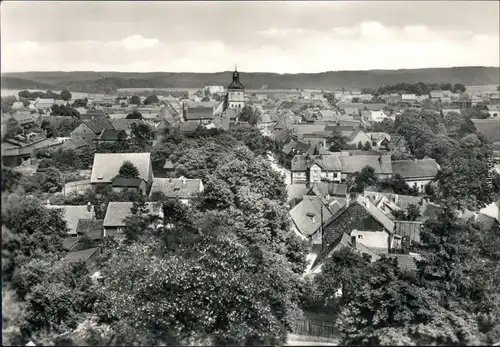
[337, 258, 480, 346]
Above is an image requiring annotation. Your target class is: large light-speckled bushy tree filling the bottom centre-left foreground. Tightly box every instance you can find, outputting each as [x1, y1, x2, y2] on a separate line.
[96, 215, 302, 344]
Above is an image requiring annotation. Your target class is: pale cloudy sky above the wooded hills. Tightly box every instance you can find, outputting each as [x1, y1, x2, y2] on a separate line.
[0, 1, 500, 73]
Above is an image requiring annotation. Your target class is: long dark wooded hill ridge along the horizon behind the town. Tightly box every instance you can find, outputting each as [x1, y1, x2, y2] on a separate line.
[2, 66, 500, 93]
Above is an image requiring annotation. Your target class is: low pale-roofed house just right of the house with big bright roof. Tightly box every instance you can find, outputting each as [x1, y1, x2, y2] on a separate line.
[149, 177, 205, 204]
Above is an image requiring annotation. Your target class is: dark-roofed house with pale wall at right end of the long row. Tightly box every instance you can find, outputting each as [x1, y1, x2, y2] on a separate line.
[392, 159, 440, 192]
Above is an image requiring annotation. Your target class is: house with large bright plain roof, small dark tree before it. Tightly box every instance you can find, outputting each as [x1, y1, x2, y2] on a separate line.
[90, 153, 153, 194]
